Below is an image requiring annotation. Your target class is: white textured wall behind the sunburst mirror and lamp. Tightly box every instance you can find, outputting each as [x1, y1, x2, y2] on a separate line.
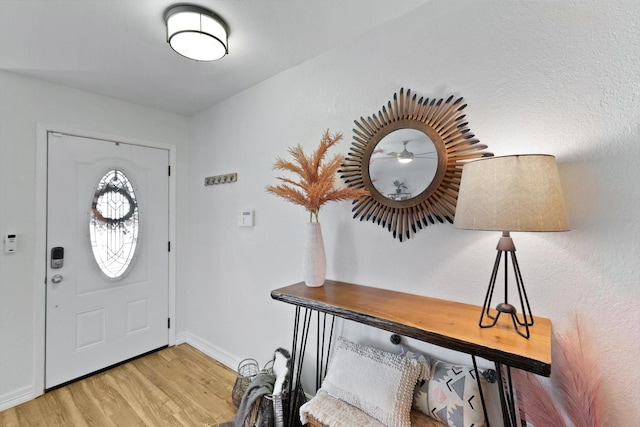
[187, 0, 640, 425]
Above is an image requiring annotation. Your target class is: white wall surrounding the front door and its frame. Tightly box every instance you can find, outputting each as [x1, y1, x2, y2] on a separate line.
[0, 71, 189, 410]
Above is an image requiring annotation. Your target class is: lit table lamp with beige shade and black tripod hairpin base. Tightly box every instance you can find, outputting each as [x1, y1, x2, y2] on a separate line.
[453, 154, 569, 339]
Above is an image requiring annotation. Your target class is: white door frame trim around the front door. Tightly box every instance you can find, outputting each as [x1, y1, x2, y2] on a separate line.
[33, 123, 176, 398]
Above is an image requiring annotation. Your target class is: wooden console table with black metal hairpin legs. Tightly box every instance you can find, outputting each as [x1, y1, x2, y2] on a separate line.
[271, 280, 551, 426]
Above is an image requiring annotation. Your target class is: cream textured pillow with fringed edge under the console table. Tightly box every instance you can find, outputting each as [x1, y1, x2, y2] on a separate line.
[321, 337, 420, 427]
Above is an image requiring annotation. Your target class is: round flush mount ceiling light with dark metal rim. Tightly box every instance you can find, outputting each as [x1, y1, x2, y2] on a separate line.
[164, 5, 229, 61]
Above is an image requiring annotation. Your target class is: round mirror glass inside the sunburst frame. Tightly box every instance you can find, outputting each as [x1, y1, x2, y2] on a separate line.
[369, 128, 438, 200]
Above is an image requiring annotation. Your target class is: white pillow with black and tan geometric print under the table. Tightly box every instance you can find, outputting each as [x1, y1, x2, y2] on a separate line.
[414, 360, 485, 427]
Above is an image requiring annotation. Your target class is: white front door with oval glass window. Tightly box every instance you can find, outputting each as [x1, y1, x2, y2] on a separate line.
[45, 133, 169, 388]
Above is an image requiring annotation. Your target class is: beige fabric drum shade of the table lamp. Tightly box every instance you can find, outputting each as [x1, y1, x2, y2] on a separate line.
[453, 154, 569, 231]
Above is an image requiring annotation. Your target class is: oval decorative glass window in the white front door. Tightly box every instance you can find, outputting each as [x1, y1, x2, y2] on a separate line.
[89, 169, 139, 279]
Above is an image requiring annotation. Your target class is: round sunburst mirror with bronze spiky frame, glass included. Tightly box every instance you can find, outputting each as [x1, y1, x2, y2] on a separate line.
[339, 89, 493, 241]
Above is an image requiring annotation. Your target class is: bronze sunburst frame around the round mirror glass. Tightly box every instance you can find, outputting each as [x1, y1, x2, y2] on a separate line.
[338, 89, 493, 242]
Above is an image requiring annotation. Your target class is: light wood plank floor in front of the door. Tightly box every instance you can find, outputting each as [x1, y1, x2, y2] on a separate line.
[0, 344, 236, 427]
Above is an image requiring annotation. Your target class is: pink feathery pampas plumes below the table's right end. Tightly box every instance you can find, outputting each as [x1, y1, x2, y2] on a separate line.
[512, 316, 606, 427]
